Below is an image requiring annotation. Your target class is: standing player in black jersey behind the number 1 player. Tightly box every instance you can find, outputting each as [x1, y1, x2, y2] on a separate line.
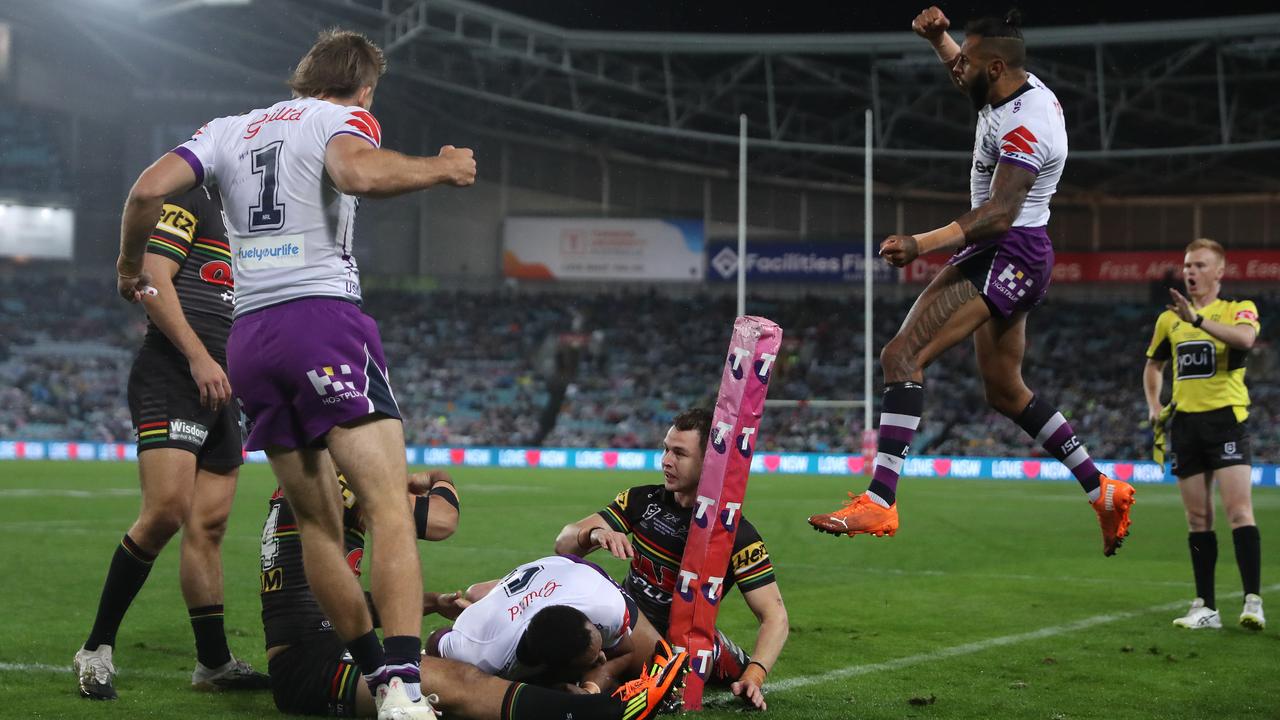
[74, 187, 268, 700]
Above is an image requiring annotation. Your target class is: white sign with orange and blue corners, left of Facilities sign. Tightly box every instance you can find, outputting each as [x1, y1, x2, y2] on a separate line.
[502, 218, 703, 282]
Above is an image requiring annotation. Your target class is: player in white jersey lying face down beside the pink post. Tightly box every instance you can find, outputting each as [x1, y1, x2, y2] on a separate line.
[426, 555, 660, 692]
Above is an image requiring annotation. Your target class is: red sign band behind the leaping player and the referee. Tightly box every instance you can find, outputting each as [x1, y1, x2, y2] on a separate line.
[901, 250, 1280, 283]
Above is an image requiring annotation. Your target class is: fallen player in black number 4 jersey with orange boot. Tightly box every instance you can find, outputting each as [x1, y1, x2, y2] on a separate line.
[261, 471, 686, 720]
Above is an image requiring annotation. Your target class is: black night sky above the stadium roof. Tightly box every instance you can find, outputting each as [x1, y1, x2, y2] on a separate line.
[481, 0, 1280, 32]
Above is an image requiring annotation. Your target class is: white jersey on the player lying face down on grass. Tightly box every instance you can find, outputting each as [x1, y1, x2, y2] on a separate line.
[439, 555, 631, 680]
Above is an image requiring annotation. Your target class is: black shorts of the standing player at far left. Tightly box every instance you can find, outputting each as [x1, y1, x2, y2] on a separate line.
[128, 345, 244, 470]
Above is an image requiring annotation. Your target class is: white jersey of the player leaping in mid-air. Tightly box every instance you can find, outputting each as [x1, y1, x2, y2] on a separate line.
[967, 73, 1066, 225]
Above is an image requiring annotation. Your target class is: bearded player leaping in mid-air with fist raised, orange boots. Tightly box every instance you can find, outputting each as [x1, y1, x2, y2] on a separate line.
[809, 8, 1133, 556]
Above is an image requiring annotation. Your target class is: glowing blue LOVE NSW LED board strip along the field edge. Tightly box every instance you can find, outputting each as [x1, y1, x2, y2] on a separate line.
[0, 439, 1280, 487]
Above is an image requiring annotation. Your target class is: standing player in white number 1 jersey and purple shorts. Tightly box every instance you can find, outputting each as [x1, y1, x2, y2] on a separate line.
[116, 31, 476, 717]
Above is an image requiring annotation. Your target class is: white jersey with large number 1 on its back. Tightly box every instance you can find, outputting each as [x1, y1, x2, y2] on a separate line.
[174, 97, 381, 315]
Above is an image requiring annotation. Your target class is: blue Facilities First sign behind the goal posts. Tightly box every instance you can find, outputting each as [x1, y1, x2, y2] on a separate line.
[707, 241, 899, 283]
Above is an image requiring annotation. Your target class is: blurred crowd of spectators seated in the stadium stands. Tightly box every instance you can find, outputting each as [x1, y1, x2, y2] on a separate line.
[0, 269, 1280, 461]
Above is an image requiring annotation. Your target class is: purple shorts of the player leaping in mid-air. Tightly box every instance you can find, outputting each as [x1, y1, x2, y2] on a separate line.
[947, 227, 1053, 318]
